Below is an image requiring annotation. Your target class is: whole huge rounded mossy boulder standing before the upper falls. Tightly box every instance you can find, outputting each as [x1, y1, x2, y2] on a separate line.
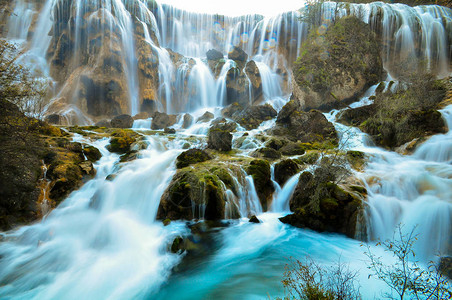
[293, 17, 383, 110]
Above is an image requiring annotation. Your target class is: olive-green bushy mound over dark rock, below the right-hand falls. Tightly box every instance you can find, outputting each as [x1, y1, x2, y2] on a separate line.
[360, 72, 446, 148]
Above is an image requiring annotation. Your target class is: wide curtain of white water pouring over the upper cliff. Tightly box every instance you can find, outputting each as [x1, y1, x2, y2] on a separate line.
[7, 0, 451, 122]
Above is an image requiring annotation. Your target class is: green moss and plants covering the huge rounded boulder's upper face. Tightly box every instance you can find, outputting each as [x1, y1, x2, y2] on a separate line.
[293, 14, 380, 94]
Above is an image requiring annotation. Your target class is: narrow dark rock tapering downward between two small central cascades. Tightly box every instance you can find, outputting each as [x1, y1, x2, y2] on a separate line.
[246, 159, 275, 211]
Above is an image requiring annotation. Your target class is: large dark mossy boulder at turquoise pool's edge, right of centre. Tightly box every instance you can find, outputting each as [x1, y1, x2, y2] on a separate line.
[280, 172, 366, 240]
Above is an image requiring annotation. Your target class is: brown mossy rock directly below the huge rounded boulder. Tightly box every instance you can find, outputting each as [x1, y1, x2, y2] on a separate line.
[271, 100, 338, 146]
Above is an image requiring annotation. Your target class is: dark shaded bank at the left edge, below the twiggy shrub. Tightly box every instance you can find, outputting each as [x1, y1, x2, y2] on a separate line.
[0, 99, 45, 230]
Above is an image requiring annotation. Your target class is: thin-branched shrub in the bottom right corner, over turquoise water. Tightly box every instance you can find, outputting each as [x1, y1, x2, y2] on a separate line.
[365, 225, 452, 300]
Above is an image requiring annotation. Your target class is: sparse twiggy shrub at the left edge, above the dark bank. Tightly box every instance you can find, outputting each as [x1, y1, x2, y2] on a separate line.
[0, 40, 48, 119]
